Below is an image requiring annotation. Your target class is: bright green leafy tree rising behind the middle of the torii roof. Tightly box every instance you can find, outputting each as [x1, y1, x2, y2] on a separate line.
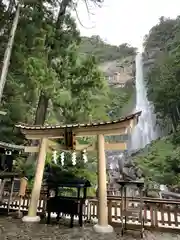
[54, 49, 109, 123]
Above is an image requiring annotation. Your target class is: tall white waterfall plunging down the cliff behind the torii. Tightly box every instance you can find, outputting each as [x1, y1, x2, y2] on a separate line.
[130, 53, 158, 150]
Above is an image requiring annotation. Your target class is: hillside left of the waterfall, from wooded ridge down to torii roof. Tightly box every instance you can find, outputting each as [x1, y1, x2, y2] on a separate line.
[80, 36, 137, 119]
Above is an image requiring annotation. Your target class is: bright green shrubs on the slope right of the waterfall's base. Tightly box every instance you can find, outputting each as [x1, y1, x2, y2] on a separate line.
[134, 138, 177, 186]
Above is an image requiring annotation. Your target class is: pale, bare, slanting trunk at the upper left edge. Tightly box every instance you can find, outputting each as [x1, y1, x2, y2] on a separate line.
[0, 4, 20, 103]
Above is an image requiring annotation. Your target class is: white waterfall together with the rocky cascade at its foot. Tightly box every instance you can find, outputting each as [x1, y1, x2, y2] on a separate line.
[107, 54, 154, 196]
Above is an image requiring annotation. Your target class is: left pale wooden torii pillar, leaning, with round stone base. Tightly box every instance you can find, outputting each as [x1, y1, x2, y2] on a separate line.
[22, 138, 47, 222]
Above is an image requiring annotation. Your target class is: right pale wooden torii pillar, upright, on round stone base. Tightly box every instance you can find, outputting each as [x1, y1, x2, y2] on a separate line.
[94, 134, 113, 233]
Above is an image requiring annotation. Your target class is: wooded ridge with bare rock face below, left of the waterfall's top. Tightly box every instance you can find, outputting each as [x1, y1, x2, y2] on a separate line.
[80, 36, 136, 87]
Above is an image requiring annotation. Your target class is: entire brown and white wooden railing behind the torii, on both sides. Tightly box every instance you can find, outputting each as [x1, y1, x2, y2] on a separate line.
[1, 191, 180, 230]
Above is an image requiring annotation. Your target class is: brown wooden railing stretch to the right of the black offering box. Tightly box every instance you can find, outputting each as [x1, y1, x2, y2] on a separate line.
[86, 196, 180, 230]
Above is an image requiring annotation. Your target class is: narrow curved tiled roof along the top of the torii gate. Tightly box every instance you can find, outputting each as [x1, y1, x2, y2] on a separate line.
[15, 111, 141, 130]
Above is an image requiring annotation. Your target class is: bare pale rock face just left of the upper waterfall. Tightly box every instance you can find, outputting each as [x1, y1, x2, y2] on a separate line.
[99, 57, 135, 88]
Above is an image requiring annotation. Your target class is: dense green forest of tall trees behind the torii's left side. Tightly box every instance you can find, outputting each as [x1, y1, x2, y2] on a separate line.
[0, 0, 136, 191]
